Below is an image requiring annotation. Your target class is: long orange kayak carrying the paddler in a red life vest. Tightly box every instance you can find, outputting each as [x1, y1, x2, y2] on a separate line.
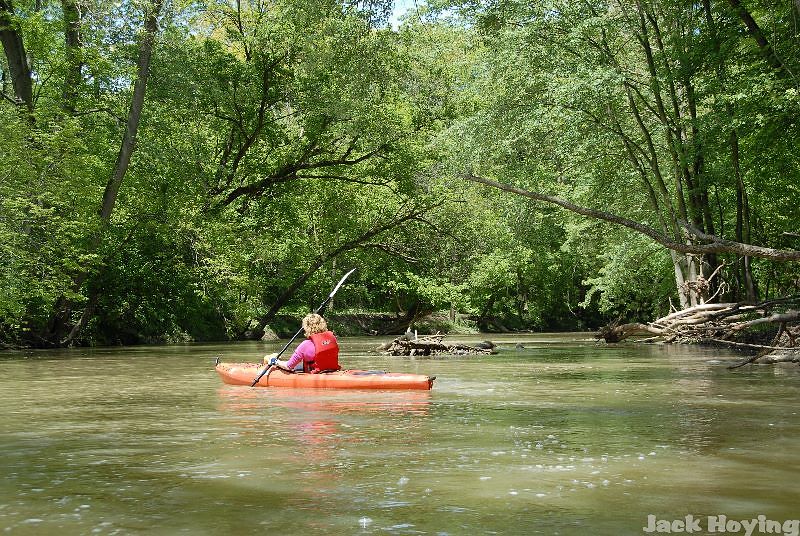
[216, 363, 436, 389]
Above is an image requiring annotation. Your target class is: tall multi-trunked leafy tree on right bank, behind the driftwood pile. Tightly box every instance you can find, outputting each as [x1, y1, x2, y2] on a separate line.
[440, 1, 800, 318]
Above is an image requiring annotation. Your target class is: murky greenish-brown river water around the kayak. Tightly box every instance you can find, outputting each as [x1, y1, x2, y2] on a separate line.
[0, 334, 800, 536]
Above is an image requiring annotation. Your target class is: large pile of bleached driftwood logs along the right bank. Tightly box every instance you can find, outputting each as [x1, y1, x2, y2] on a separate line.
[595, 298, 800, 368]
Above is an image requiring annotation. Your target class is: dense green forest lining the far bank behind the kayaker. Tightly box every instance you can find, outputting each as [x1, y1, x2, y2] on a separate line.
[0, 0, 800, 347]
